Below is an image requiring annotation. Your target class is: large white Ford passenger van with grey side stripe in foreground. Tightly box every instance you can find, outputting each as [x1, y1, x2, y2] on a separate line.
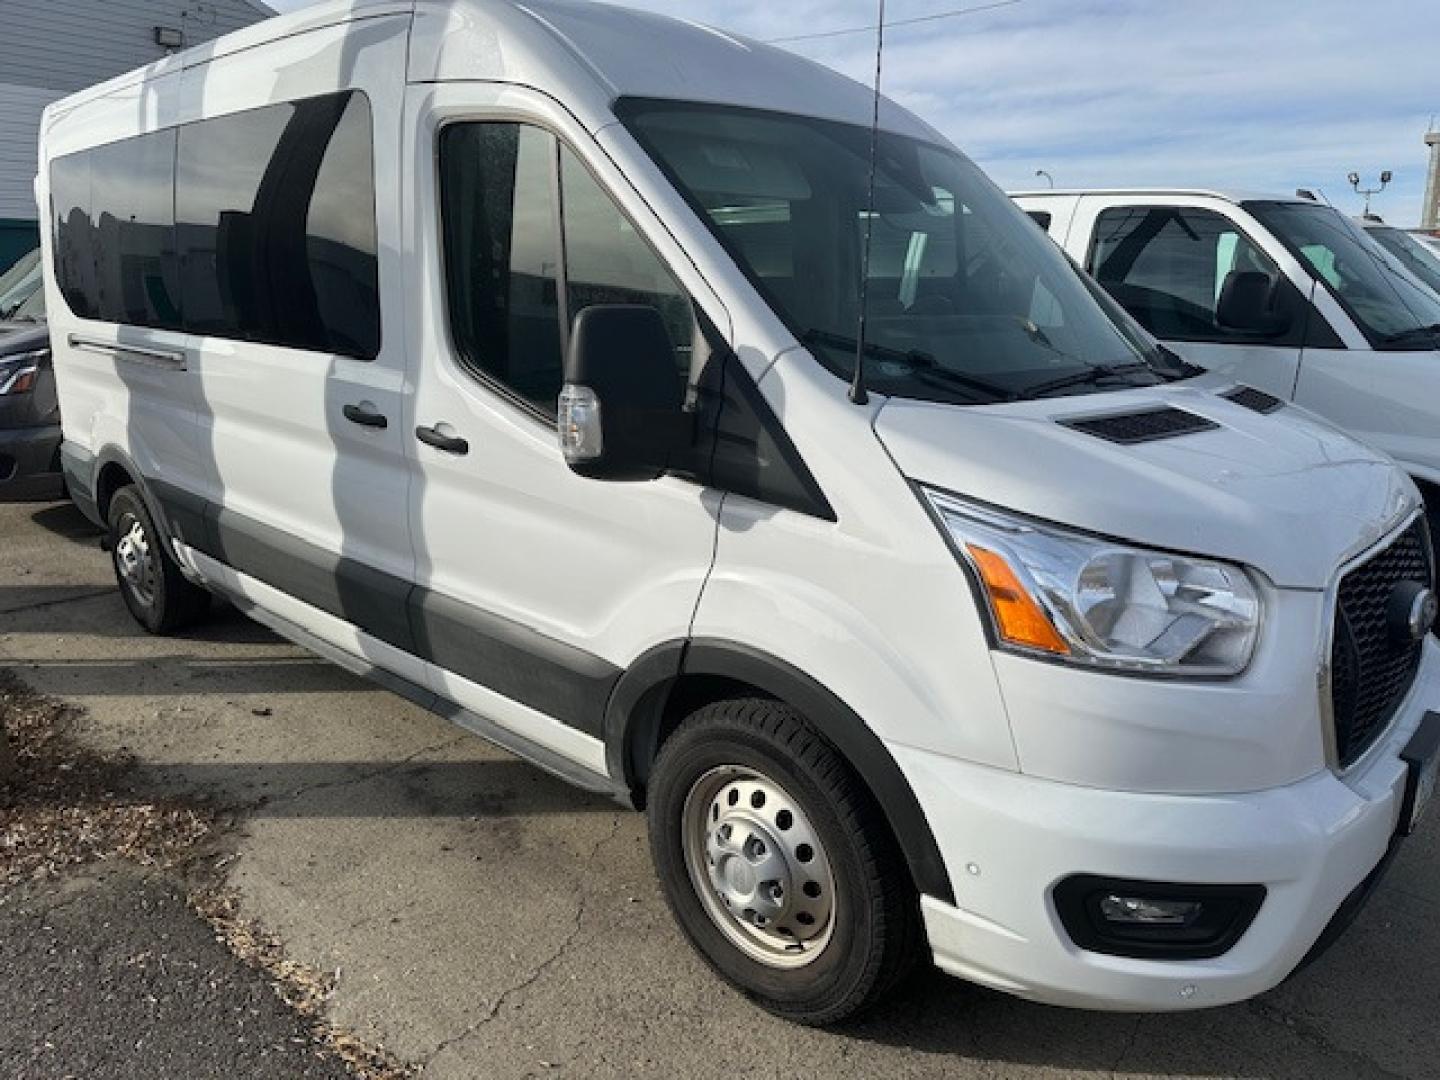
[39, 0, 1440, 1022]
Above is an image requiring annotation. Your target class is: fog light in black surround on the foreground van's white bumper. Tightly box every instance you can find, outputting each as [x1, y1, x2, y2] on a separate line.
[1054, 874, 1266, 960]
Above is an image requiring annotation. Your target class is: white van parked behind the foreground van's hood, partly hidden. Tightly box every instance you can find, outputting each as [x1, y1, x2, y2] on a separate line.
[1015, 190, 1440, 544]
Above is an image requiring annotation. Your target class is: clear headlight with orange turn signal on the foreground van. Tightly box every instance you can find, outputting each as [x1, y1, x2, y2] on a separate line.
[922, 487, 1261, 675]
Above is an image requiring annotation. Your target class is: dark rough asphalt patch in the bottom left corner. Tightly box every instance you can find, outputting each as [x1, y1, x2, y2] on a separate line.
[0, 865, 348, 1080]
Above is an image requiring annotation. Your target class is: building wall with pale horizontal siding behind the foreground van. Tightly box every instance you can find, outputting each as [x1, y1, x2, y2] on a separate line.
[0, 0, 271, 271]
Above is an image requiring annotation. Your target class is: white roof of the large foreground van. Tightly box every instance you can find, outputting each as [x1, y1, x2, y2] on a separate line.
[49, 0, 945, 141]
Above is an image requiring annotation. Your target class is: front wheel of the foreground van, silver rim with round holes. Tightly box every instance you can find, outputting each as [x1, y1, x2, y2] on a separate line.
[648, 700, 920, 1024]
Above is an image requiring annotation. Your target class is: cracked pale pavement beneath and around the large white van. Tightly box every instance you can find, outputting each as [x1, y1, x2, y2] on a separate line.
[0, 504, 1440, 1080]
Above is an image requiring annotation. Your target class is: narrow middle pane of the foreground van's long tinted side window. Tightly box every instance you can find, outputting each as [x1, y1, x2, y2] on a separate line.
[88, 131, 180, 330]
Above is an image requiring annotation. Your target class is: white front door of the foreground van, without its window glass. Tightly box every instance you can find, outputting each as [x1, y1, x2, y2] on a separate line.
[399, 82, 729, 736]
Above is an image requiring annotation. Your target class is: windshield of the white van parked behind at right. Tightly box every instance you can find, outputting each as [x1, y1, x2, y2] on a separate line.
[1244, 202, 1440, 350]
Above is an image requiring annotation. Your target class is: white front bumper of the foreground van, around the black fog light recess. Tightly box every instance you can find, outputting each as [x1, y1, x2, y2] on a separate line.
[891, 638, 1440, 1011]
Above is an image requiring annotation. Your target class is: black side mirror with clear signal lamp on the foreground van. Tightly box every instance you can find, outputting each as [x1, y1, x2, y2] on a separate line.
[560, 304, 690, 480]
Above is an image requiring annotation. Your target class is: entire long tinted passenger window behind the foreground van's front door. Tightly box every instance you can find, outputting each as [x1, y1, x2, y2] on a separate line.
[50, 92, 380, 359]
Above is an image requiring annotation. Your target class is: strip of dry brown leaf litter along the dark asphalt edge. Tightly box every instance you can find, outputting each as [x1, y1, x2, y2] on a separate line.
[0, 671, 419, 1080]
